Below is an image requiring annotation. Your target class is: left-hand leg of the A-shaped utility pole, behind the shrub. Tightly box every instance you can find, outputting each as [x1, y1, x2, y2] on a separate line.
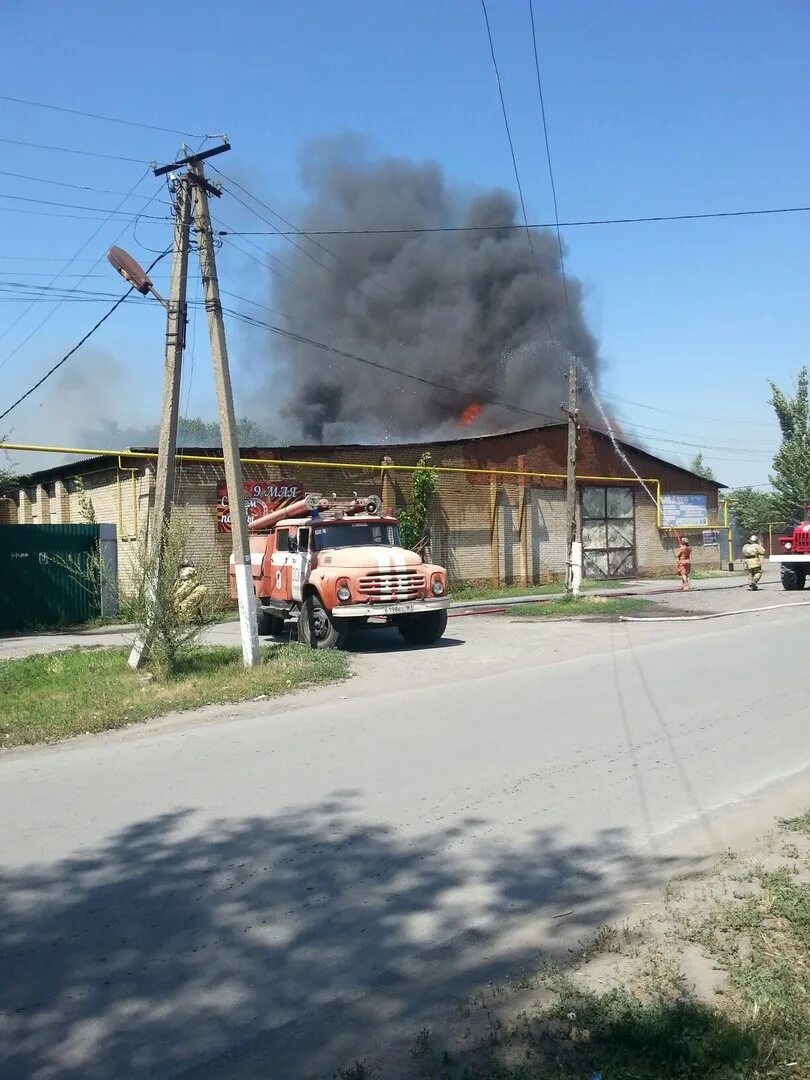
[130, 176, 191, 670]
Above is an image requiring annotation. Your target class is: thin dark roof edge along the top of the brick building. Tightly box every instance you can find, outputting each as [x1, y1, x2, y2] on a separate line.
[12, 421, 726, 489]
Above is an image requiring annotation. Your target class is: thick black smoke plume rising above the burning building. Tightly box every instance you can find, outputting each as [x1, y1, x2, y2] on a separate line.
[263, 137, 598, 442]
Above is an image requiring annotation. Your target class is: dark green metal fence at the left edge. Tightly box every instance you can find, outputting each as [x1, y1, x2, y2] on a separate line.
[0, 525, 102, 634]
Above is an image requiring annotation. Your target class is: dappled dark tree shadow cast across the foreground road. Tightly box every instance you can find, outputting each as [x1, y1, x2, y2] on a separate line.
[0, 792, 704, 1080]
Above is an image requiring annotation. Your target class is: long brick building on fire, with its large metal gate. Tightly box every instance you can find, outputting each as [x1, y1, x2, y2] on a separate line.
[0, 423, 725, 583]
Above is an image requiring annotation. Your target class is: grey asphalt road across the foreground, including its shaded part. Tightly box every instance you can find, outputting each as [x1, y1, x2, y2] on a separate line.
[0, 593, 810, 1080]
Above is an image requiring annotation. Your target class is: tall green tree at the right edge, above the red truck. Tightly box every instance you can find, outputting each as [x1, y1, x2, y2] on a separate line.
[770, 367, 810, 522]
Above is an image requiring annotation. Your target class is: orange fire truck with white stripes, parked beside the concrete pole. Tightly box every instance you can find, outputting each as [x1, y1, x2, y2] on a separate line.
[230, 496, 449, 649]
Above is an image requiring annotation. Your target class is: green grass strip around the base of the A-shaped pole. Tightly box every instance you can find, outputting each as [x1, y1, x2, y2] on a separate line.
[0, 645, 349, 747]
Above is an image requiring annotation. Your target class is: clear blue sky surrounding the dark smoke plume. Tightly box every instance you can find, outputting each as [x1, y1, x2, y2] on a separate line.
[0, 0, 810, 485]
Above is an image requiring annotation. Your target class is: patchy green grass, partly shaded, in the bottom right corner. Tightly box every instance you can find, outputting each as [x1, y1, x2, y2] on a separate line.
[420, 867, 810, 1080]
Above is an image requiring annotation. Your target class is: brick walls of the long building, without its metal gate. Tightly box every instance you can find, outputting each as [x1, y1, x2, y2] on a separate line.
[11, 426, 720, 588]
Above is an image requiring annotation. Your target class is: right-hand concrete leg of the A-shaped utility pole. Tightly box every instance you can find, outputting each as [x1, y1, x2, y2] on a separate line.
[188, 159, 259, 667]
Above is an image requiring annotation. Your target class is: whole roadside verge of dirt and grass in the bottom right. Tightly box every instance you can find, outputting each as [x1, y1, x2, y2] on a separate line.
[334, 814, 810, 1080]
